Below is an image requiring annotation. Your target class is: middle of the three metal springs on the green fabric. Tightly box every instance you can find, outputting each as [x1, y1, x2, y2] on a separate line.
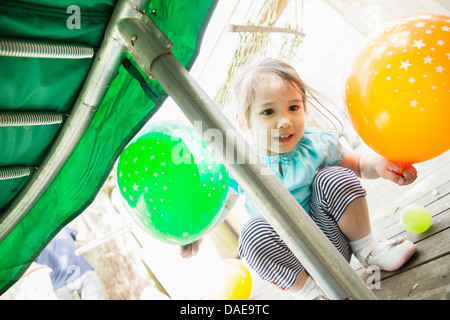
[0, 112, 63, 127]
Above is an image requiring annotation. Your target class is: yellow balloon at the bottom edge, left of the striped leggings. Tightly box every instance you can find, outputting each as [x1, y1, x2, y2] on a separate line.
[210, 259, 252, 300]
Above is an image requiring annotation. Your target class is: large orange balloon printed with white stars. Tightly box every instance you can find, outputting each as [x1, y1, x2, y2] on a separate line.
[343, 14, 450, 167]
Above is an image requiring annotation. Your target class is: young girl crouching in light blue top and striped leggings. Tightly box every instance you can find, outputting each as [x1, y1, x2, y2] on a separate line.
[182, 59, 417, 299]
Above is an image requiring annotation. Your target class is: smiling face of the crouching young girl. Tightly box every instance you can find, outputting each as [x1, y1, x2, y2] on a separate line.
[248, 74, 305, 156]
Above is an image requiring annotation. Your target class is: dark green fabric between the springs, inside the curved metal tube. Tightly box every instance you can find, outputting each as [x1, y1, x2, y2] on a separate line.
[0, 0, 115, 211]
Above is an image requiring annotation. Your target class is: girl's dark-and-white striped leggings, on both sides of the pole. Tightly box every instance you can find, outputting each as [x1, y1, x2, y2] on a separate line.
[238, 167, 366, 290]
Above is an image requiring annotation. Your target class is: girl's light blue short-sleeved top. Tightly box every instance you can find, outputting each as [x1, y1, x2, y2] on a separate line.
[230, 128, 345, 217]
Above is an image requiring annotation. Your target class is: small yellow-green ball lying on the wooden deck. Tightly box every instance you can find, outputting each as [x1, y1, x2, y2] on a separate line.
[400, 204, 431, 233]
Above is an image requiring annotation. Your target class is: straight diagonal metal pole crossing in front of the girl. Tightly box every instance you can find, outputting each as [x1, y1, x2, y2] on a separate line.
[119, 19, 376, 300]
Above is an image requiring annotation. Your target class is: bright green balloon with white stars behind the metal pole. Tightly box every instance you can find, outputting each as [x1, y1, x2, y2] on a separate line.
[117, 123, 229, 245]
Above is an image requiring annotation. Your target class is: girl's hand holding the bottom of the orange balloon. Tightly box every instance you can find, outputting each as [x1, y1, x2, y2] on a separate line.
[377, 157, 417, 186]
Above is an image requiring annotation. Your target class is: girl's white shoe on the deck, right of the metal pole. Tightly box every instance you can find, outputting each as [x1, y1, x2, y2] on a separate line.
[355, 236, 417, 271]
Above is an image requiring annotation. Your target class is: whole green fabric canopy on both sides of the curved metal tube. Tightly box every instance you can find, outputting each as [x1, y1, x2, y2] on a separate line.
[0, 0, 217, 295]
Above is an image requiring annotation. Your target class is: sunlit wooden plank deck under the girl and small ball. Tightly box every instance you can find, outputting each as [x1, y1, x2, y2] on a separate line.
[250, 152, 450, 300]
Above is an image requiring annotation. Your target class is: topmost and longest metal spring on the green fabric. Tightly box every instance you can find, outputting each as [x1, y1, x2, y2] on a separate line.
[0, 38, 94, 59]
